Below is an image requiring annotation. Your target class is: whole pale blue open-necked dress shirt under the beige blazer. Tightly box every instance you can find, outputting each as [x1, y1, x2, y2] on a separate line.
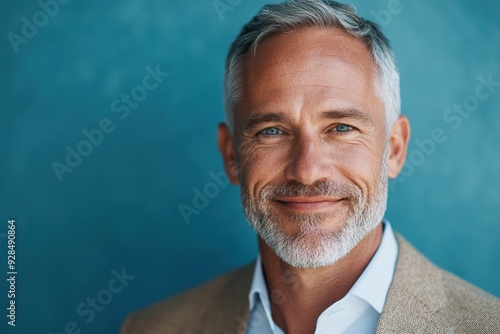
[247, 220, 398, 334]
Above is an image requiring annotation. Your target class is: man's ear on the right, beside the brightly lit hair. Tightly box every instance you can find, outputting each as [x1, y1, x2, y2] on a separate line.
[387, 115, 410, 179]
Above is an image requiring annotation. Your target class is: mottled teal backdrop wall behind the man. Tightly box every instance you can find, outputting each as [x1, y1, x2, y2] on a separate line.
[0, 0, 500, 334]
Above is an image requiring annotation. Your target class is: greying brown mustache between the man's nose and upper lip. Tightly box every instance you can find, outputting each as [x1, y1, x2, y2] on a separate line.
[260, 180, 362, 200]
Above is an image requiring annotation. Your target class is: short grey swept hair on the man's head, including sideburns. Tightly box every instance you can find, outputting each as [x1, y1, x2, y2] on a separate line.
[224, 0, 401, 131]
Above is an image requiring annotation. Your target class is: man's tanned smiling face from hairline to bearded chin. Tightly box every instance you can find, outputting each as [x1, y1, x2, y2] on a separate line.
[219, 28, 408, 267]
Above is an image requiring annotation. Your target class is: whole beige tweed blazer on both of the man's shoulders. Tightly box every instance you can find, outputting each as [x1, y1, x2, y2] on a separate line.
[121, 235, 500, 334]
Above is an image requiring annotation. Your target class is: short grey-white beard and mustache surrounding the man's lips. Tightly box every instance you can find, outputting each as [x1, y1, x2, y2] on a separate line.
[241, 146, 388, 268]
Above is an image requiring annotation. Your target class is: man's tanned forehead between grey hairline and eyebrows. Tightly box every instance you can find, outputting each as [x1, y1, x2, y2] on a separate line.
[235, 27, 377, 117]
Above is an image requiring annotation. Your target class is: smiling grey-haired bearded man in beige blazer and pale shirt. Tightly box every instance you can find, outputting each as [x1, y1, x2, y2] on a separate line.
[122, 0, 500, 334]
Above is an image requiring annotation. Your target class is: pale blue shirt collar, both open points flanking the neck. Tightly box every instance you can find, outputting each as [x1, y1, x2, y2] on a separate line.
[248, 219, 398, 319]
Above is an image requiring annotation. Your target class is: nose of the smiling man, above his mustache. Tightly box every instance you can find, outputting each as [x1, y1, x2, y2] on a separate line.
[285, 134, 332, 185]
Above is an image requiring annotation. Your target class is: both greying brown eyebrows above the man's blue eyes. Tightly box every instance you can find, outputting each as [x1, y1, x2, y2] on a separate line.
[243, 109, 373, 131]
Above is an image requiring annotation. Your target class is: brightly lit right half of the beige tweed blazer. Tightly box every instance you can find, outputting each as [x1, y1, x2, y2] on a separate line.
[378, 235, 500, 332]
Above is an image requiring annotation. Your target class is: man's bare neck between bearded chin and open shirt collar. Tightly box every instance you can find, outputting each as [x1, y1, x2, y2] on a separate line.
[259, 224, 382, 334]
